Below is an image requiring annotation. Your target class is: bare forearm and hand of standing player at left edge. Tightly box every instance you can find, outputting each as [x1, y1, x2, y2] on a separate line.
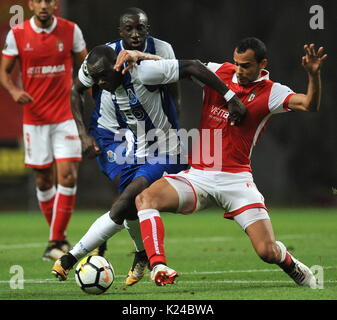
[0, 56, 34, 104]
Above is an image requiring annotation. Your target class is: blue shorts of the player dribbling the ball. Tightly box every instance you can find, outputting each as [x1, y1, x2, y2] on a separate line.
[118, 156, 188, 193]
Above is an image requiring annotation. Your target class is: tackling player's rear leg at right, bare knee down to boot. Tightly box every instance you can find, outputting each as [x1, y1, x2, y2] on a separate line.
[240, 209, 316, 288]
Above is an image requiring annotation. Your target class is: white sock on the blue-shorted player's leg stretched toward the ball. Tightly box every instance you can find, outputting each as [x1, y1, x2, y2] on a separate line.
[69, 212, 124, 260]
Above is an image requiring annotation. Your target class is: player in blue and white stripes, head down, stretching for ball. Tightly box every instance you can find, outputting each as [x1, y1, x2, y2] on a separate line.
[52, 45, 246, 280]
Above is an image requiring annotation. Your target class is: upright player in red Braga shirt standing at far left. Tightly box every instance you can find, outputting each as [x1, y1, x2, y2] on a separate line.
[0, 0, 87, 260]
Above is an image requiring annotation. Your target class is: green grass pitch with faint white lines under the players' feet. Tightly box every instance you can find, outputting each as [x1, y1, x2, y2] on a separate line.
[0, 208, 337, 300]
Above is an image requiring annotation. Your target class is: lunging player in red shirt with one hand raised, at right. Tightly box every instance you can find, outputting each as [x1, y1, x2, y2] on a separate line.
[131, 38, 327, 288]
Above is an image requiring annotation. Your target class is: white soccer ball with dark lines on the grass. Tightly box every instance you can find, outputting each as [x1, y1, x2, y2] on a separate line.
[75, 256, 115, 294]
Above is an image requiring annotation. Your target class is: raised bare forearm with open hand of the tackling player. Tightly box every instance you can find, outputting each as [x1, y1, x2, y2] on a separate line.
[288, 43, 328, 112]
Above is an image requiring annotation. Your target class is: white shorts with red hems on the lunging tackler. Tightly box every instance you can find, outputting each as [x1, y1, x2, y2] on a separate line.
[164, 168, 269, 226]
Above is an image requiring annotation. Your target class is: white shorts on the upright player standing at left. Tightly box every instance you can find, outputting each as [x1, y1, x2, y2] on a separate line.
[23, 120, 82, 169]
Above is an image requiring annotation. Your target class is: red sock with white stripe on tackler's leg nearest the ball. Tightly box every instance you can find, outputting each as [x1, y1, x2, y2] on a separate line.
[138, 209, 166, 268]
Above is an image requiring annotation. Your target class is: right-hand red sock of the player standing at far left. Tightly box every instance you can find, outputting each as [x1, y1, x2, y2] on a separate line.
[49, 185, 76, 241]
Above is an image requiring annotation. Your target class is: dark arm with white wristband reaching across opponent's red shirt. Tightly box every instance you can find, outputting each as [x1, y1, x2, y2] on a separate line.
[179, 60, 247, 125]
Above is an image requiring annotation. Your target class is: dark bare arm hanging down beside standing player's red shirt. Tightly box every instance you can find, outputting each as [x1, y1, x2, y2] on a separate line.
[71, 78, 100, 158]
